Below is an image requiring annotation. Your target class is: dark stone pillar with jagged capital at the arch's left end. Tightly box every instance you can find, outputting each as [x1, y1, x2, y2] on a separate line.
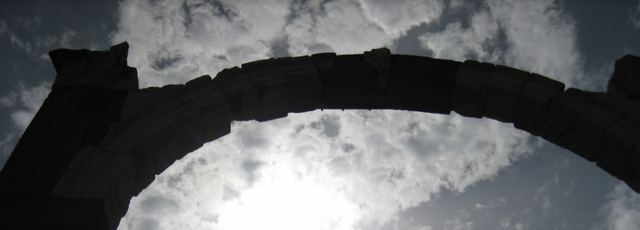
[0, 42, 138, 229]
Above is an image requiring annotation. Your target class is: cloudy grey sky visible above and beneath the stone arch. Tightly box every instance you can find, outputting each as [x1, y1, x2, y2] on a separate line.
[0, 0, 640, 230]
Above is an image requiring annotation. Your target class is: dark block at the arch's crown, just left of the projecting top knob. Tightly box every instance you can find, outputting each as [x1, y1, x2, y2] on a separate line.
[323, 55, 378, 109]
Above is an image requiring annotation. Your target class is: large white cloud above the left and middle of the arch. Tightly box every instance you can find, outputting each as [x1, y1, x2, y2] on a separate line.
[111, 0, 442, 87]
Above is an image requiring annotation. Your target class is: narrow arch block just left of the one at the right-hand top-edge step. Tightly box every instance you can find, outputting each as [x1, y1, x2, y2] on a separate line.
[484, 65, 530, 123]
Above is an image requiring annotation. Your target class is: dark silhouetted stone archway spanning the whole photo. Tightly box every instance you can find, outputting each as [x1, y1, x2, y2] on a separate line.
[0, 43, 640, 229]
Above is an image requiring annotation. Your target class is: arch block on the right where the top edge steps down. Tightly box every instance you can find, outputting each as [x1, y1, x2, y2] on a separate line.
[514, 74, 564, 136]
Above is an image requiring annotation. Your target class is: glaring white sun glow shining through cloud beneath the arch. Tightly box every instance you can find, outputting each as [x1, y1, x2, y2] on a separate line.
[218, 157, 358, 230]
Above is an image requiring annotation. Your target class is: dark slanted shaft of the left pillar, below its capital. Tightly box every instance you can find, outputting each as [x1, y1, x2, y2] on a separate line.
[0, 88, 127, 197]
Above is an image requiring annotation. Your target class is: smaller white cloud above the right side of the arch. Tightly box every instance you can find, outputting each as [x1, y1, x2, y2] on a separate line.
[420, 0, 592, 88]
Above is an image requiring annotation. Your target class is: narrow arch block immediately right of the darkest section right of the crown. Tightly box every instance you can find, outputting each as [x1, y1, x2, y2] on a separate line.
[453, 60, 495, 118]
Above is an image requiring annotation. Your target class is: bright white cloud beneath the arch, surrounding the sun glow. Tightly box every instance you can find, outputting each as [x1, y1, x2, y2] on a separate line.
[121, 110, 531, 229]
